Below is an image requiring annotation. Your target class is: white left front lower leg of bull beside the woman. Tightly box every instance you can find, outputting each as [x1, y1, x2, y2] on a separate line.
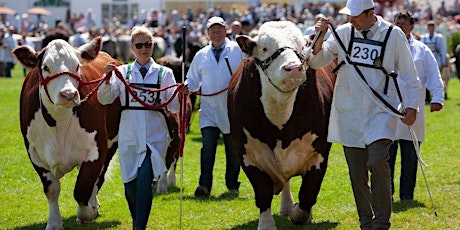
[41, 172, 64, 230]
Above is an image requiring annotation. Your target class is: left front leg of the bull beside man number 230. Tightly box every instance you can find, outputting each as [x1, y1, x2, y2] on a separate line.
[242, 166, 276, 230]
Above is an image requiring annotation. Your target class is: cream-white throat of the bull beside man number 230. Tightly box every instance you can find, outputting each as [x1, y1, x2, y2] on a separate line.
[260, 77, 298, 130]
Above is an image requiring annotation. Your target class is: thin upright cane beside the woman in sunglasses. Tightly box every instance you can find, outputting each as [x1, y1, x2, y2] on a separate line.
[179, 26, 187, 229]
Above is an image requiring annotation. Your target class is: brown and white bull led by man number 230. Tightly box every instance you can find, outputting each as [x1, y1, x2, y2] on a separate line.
[228, 22, 335, 229]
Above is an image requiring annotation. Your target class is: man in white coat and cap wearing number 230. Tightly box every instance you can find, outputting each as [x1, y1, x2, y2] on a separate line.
[309, 0, 422, 229]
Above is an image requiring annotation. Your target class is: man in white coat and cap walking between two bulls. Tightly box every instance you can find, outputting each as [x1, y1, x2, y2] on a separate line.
[184, 17, 244, 197]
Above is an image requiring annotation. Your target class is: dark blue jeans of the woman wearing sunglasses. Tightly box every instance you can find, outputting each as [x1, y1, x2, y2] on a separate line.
[124, 148, 153, 230]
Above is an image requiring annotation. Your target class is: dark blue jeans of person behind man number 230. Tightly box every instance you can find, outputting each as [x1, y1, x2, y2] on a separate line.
[388, 140, 420, 200]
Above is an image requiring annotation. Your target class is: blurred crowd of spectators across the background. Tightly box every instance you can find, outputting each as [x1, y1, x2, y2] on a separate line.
[0, 0, 460, 79]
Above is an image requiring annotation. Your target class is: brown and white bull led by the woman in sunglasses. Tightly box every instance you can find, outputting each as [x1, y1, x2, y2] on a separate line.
[13, 38, 121, 229]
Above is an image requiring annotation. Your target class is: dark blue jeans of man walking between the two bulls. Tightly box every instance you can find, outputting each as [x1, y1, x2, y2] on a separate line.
[199, 127, 240, 192]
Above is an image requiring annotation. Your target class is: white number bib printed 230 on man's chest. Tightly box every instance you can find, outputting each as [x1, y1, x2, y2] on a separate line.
[351, 38, 383, 68]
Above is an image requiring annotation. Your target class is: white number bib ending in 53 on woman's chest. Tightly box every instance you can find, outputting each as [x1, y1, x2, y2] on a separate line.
[126, 83, 160, 109]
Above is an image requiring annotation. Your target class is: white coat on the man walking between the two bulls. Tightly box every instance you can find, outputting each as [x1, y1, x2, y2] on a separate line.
[185, 38, 244, 134]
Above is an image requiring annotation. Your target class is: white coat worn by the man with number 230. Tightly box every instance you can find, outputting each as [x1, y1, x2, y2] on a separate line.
[309, 16, 421, 148]
